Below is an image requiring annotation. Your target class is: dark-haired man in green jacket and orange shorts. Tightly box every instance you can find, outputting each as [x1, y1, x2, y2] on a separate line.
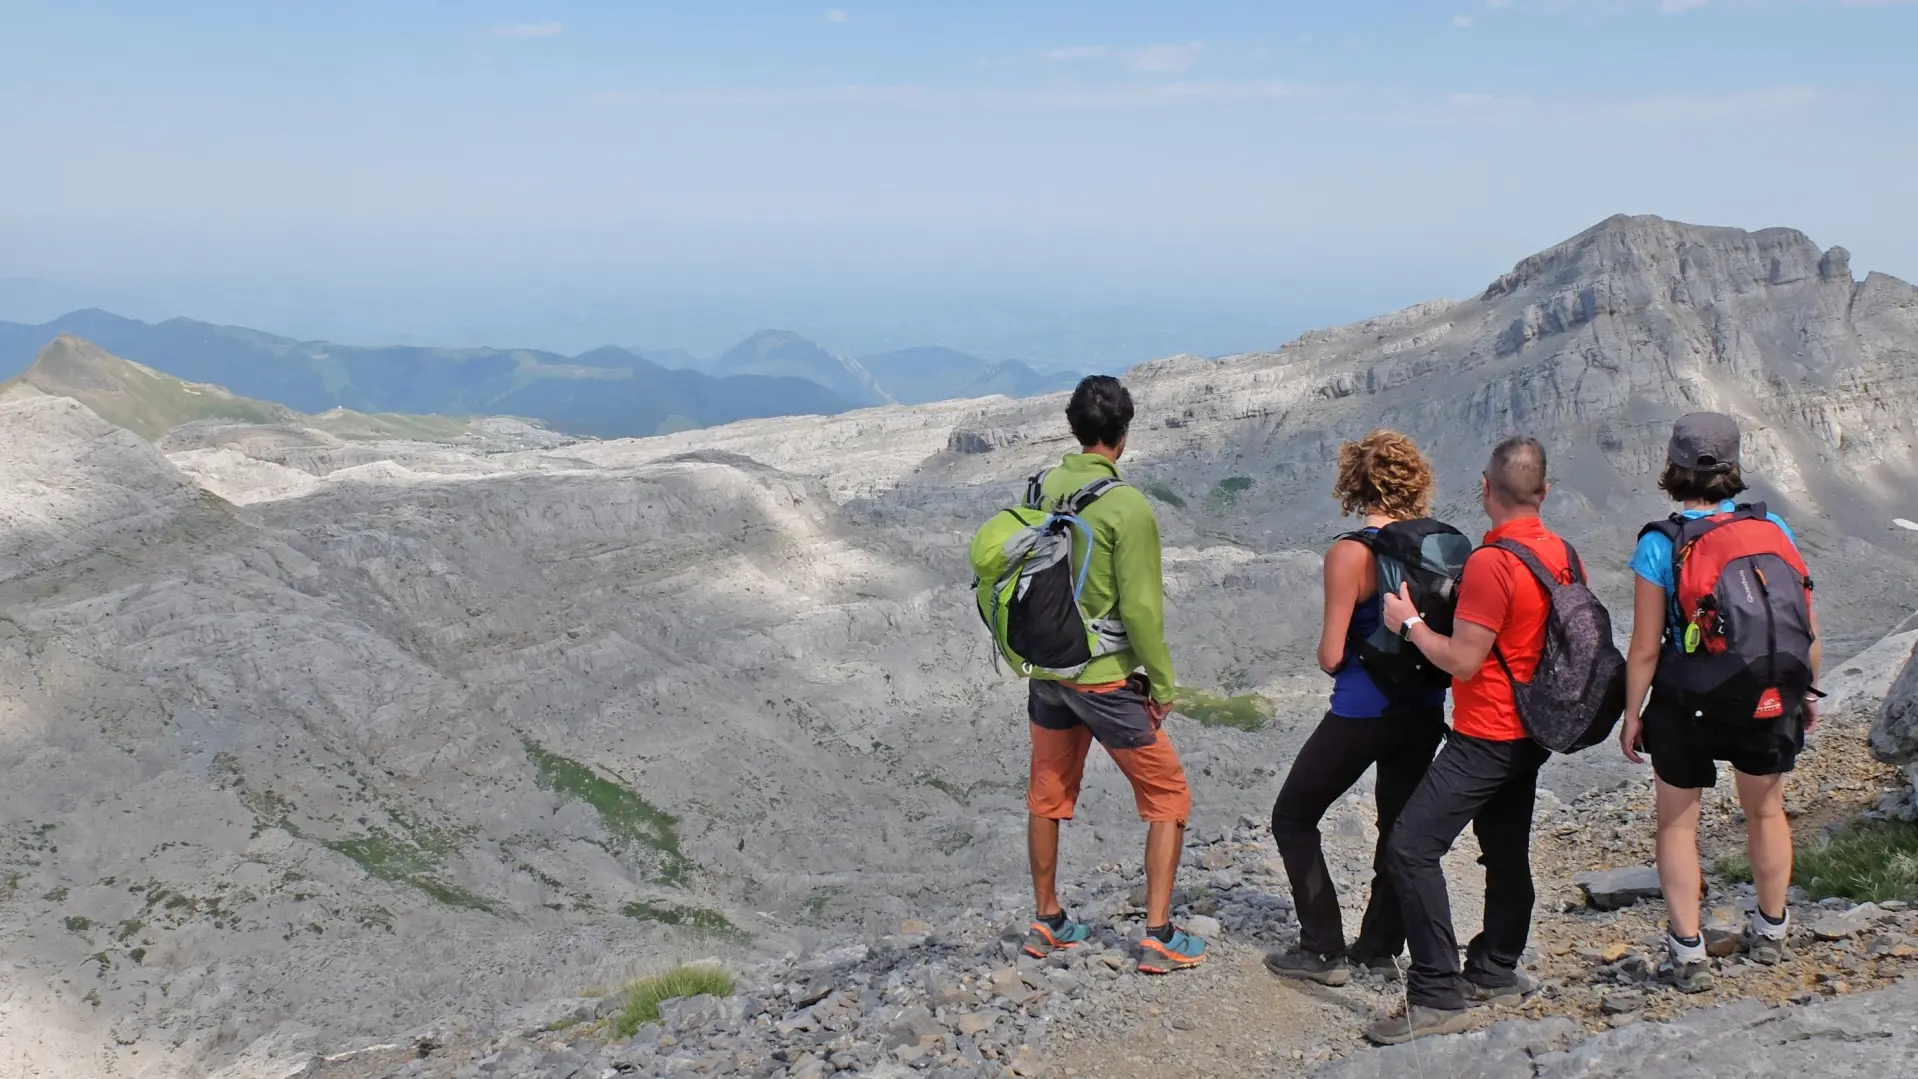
[1026, 376, 1205, 974]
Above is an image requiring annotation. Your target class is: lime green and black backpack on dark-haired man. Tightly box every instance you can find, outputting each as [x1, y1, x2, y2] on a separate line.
[971, 471, 1128, 680]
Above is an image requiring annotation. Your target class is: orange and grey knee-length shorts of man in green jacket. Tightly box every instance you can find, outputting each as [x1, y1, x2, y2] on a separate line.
[1026, 682, 1193, 824]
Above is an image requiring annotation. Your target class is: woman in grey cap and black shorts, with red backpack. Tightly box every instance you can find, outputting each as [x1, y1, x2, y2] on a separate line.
[1619, 412, 1818, 993]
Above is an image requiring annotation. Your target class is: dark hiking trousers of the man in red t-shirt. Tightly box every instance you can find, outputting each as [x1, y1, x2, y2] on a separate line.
[1385, 732, 1552, 1010]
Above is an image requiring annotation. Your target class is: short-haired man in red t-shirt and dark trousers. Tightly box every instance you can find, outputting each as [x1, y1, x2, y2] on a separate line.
[1366, 437, 1571, 1045]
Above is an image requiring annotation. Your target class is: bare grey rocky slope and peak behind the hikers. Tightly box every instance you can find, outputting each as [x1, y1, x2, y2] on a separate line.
[0, 218, 1918, 1075]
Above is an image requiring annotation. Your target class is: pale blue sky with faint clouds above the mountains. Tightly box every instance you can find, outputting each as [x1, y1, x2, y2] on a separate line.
[0, 0, 1918, 354]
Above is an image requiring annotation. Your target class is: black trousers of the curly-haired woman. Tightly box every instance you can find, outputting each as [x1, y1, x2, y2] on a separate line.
[1272, 707, 1444, 958]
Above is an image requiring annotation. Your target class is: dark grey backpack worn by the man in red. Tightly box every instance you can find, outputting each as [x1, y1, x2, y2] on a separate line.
[1492, 540, 1625, 753]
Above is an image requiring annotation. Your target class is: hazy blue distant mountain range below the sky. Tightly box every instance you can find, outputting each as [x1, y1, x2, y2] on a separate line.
[0, 309, 1076, 439]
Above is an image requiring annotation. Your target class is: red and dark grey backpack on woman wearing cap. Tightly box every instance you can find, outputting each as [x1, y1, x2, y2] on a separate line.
[1638, 502, 1814, 723]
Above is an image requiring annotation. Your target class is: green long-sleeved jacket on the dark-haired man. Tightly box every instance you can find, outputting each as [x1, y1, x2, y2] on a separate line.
[1043, 454, 1174, 703]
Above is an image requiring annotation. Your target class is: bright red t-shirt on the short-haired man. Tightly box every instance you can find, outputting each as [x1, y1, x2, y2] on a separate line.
[1452, 517, 1582, 742]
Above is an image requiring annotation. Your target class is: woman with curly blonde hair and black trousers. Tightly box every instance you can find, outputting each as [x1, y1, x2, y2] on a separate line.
[1266, 429, 1444, 985]
